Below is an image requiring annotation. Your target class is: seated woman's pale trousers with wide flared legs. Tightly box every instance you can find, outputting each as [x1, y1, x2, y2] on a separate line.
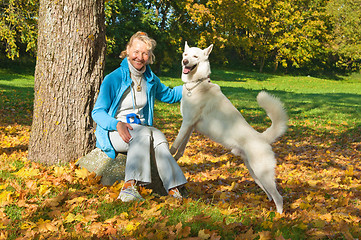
[109, 124, 187, 191]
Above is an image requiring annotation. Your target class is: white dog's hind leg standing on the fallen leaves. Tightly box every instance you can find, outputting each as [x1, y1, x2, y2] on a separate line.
[245, 141, 283, 213]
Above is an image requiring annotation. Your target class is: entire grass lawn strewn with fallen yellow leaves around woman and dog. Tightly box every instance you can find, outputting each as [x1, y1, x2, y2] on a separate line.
[0, 64, 361, 239]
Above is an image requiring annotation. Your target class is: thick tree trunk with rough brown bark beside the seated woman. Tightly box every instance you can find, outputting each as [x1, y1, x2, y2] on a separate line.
[28, 0, 105, 165]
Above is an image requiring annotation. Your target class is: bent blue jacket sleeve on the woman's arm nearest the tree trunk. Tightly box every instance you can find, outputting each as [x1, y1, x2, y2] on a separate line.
[92, 75, 118, 131]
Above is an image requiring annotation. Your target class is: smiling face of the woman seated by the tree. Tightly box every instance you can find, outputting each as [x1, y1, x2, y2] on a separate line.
[127, 39, 150, 70]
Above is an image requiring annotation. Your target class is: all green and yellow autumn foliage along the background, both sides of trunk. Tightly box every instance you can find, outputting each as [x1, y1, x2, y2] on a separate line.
[0, 0, 361, 73]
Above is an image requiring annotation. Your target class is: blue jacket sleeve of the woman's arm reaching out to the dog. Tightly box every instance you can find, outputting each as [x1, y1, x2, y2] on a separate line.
[154, 76, 183, 103]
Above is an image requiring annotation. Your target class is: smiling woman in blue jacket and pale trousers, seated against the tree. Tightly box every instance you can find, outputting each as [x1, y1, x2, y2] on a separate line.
[92, 32, 187, 202]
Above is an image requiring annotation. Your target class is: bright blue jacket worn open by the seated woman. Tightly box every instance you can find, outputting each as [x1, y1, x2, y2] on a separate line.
[92, 59, 182, 159]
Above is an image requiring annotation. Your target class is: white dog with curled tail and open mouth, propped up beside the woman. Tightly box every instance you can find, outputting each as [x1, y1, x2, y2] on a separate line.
[170, 42, 288, 213]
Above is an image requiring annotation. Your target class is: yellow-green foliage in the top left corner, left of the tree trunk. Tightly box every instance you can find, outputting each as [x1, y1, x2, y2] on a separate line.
[0, 0, 39, 59]
